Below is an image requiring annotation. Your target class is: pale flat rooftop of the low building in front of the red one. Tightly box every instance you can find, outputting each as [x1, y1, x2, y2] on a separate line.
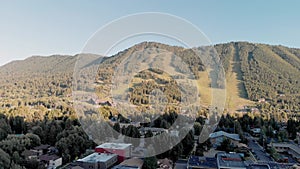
[77, 153, 117, 163]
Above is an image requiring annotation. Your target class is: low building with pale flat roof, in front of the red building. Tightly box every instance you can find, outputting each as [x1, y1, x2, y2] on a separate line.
[76, 153, 118, 169]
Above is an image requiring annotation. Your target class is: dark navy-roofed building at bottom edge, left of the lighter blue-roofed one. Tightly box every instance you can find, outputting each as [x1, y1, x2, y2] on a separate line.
[187, 156, 218, 169]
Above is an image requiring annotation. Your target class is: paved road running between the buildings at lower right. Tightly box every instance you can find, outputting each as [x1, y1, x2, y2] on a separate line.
[247, 136, 274, 161]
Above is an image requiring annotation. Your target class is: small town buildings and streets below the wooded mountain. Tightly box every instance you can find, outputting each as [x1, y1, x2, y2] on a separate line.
[19, 109, 300, 169]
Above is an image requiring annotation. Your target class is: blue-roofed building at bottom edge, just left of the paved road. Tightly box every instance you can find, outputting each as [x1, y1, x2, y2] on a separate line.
[216, 152, 247, 169]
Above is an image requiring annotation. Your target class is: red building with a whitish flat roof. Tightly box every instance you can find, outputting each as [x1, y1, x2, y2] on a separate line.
[95, 143, 132, 162]
